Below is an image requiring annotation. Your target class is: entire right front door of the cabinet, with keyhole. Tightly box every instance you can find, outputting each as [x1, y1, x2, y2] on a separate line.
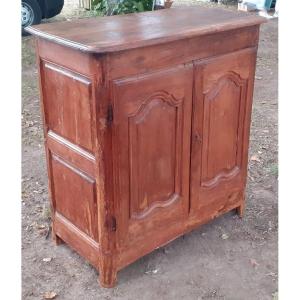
[191, 49, 256, 215]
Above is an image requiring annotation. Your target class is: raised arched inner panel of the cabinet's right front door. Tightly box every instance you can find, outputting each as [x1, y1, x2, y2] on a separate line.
[200, 73, 246, 188]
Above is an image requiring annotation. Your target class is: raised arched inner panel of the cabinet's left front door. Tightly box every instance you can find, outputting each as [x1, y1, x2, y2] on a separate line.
[129, 92, 182, 219]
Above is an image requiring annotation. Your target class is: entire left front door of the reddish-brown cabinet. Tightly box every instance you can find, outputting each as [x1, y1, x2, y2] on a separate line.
[112, 65, 193, 254]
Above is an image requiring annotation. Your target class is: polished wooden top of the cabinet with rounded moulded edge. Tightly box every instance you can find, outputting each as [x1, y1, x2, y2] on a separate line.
[27, 6, 265, 53]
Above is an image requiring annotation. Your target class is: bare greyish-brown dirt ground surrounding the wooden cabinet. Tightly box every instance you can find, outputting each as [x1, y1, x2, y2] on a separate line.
[22, 0, 278, 300]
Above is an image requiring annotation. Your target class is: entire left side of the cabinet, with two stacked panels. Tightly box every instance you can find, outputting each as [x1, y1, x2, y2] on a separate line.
[37, 41, 101, 268]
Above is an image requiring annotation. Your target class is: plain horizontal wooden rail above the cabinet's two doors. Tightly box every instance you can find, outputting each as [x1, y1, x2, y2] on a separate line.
[109, 25, 259, 78]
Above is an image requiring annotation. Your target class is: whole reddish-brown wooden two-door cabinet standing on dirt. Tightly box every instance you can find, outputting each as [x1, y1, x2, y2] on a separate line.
[28, 7, 264, 287]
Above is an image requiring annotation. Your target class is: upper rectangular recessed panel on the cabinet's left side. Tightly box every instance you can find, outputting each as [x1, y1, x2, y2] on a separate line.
[42, 61, 93, 152]
